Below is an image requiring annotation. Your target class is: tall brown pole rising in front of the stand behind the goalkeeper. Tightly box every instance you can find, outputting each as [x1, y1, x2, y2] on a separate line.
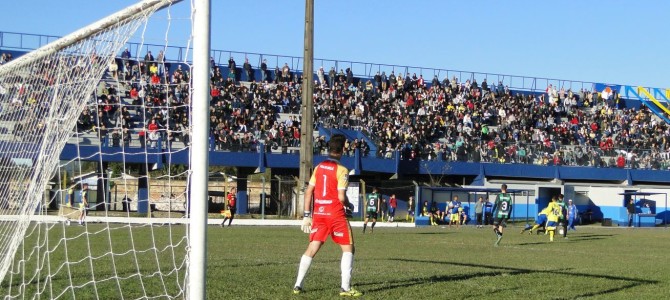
[295, 0, 314, 217]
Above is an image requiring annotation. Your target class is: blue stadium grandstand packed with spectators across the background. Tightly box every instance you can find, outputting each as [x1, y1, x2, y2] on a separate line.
[0, 33, 670, 227]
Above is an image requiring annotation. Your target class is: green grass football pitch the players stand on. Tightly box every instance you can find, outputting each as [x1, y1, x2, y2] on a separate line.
[2, 224, 670, 299]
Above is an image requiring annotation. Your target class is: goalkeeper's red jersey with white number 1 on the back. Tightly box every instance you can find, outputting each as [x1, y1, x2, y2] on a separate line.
[309, 158, 349, 217]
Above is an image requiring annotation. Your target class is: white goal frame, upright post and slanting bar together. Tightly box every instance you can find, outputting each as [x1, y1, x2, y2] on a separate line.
[0, 0, 211, 299]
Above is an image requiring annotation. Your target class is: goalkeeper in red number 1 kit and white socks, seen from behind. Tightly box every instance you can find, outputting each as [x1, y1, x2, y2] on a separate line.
[293, 134, 362, 297]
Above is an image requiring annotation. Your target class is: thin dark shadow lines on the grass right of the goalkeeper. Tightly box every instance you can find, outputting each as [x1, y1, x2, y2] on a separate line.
[368, 259, 659, 298]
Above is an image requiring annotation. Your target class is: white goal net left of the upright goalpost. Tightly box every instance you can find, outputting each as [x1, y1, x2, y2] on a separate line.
[0, 0, 206, 299]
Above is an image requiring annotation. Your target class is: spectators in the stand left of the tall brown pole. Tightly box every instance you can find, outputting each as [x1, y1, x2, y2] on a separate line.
[77, 49, 318, 153]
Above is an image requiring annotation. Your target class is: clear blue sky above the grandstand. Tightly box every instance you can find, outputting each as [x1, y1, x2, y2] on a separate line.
[0, 0, 670, 88]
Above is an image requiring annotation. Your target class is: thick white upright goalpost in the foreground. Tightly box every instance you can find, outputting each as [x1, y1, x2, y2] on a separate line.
[187, 0, 211, 300]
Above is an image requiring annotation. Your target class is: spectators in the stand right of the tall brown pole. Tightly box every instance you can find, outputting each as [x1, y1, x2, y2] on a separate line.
[315, 71, 670, 169]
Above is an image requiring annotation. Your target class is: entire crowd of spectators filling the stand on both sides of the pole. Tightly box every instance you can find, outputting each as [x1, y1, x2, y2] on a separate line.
[64, 50, 670, 169]
